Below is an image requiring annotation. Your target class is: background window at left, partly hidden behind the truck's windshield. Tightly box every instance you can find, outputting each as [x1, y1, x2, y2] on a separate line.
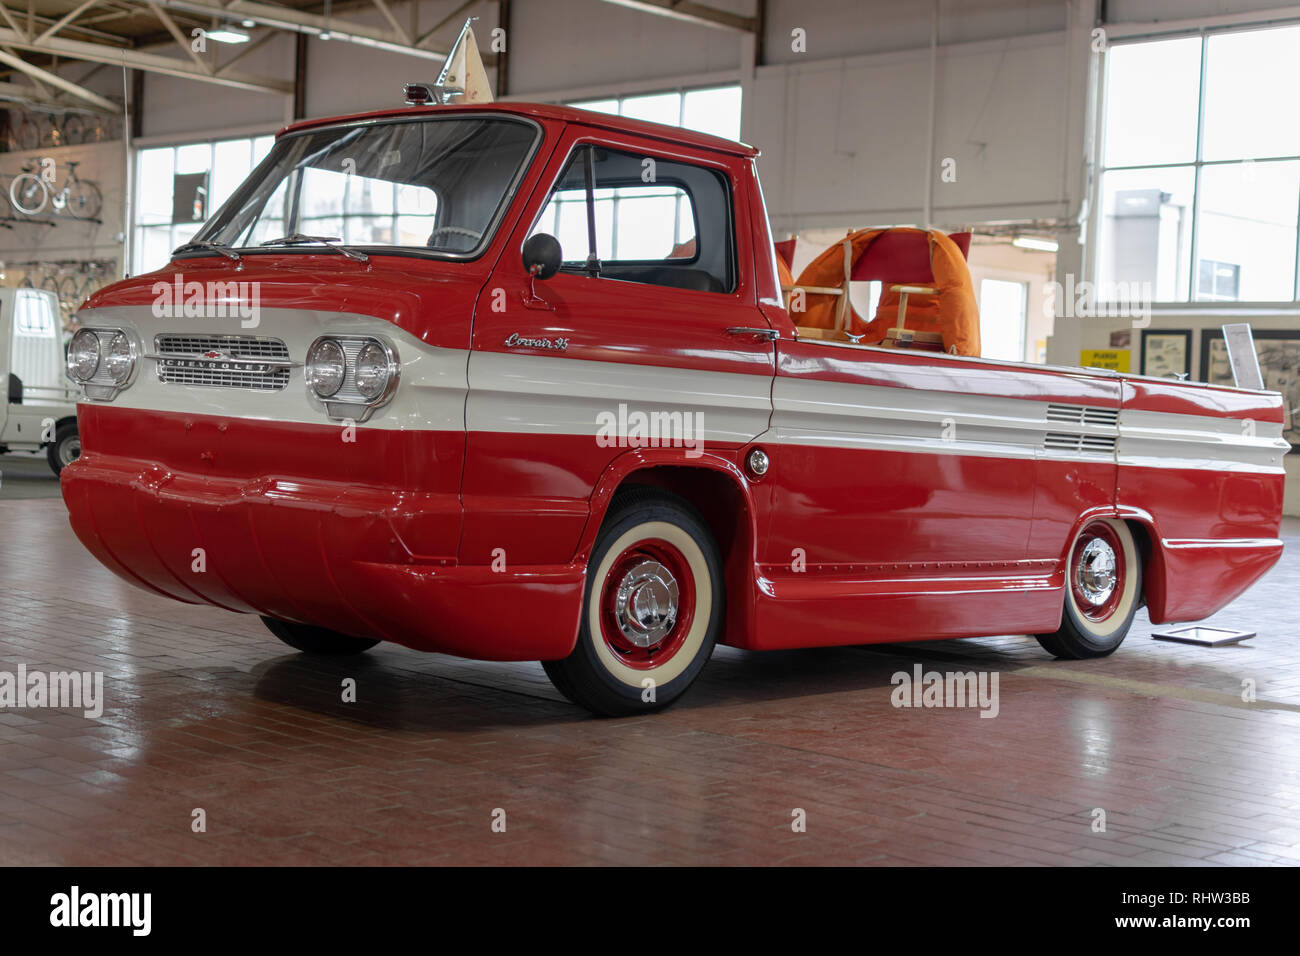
[131, 137, 276, 274]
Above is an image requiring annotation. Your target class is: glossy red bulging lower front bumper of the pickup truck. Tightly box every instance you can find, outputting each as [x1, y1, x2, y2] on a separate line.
[62, 449, 585, 661]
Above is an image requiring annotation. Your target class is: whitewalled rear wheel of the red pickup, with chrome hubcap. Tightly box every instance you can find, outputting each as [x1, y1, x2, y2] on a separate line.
[1037, 518, 1141, 661]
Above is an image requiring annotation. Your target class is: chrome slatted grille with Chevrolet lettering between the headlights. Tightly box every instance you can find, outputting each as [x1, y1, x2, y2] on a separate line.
[150, 332, 290, 392]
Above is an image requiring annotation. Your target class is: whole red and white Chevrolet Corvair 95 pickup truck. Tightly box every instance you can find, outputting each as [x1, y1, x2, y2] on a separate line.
[62, 103, 1288, 714]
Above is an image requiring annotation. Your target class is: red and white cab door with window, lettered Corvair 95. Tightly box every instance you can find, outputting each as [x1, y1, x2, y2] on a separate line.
[460, 126, 775, 564]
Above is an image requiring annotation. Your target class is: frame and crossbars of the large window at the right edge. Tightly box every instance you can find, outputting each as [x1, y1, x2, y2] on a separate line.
[1084, 17, 1300, 306]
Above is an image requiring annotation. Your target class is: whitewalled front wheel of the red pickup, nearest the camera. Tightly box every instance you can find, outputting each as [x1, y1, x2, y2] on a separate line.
[542, 488, 723, 717]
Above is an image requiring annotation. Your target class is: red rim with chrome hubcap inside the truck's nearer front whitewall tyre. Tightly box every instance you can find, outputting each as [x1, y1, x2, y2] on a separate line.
[599, 538, 696, 670]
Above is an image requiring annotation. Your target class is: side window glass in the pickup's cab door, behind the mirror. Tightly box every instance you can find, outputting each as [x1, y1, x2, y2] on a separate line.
[532, 146, 736, 293]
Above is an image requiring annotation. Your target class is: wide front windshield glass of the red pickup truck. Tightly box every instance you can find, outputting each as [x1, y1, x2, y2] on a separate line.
[195, 116, 540, 258]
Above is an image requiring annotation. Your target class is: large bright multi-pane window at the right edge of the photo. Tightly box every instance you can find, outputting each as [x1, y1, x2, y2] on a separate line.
[1096, 26, 1300, 302]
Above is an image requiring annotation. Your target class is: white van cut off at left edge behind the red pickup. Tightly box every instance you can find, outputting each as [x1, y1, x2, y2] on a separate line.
[0, 289, 81, 475]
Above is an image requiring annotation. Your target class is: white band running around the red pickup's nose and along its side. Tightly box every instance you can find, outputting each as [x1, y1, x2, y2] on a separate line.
[82, 306, 1290, 473]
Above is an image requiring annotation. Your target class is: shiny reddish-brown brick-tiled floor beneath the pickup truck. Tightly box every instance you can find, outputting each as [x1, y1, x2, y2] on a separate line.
[0, 501, 1300, 865]
